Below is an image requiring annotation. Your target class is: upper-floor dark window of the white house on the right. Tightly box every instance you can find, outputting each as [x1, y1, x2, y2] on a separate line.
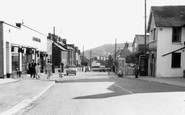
[172, 27, 181, 42]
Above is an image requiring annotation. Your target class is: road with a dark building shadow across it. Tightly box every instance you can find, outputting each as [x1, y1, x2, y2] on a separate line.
[19, 72, 185, 115]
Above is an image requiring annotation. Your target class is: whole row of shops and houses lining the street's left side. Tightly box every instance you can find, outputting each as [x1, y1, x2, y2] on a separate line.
[0, 21, 81, 78]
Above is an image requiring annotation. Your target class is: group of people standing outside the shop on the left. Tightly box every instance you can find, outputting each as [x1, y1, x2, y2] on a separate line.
[27, 60, 52, 79]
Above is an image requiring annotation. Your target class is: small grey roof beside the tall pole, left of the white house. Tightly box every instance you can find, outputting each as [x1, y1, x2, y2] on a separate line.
[132, 35, 149, 45]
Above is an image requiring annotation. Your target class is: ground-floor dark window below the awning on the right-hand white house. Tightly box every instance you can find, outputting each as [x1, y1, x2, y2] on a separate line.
[172, 53, 181, 68]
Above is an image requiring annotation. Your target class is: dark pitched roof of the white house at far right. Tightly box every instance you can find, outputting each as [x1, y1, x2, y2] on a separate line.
[149, 6, 185, 27]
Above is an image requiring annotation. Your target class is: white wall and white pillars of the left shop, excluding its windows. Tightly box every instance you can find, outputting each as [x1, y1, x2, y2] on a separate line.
[3, 24, 47, 75]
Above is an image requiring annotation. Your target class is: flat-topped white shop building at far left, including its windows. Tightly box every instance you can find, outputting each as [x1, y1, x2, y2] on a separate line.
[0, 21, 47, 77]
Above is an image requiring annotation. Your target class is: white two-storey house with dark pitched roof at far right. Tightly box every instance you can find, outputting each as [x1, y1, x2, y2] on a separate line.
[148, 6, 185, 77]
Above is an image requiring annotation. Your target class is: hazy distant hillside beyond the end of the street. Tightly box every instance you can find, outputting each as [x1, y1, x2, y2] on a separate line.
[84, 43, 131, 59]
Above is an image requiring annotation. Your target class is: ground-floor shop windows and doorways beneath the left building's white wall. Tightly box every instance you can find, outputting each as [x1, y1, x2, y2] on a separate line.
[10, 45, 49, 77]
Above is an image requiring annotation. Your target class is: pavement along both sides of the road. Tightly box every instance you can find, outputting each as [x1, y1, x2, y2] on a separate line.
[0, 73, 185, 115]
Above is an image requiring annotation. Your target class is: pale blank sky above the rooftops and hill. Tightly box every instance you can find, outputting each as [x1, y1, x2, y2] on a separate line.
[0, 0, 185, 51]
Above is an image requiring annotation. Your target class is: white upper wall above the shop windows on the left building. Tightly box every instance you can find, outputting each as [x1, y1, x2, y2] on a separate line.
[4, 24, 47, 52]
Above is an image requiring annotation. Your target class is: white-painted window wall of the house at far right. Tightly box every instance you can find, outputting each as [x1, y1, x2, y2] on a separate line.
[156, 27, 185, 77]
